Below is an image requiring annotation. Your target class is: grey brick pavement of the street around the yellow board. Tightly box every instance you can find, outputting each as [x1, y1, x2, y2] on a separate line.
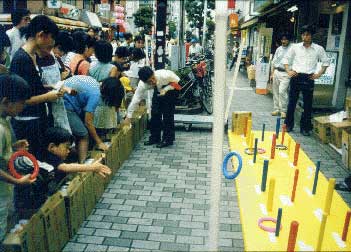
[64, 69, 351, 251]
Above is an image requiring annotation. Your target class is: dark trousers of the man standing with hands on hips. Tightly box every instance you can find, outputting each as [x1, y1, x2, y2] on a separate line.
[285, 74, 314, 131]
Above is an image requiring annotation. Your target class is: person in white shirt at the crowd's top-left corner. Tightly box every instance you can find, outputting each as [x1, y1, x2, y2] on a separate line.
[6, 9, 30, 60]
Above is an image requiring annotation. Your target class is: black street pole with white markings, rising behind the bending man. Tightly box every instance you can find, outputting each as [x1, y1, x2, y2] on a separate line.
[155, 0, 167, 70]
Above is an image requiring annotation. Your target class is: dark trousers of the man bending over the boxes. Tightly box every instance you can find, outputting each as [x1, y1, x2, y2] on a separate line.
[150, 88, 177, 142]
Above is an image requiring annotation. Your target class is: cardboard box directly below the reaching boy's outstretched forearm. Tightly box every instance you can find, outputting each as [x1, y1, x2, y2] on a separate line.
[60, 176, 86, 238]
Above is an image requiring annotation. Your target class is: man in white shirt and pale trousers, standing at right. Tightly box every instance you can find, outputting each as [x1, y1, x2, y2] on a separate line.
[271, 33, 291, 119]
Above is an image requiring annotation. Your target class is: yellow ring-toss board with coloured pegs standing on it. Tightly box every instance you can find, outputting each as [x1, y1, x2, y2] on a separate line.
[228, 131, 351, 251]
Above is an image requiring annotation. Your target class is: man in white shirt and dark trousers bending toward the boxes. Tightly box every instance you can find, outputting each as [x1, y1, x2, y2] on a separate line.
[124, 66, 181, 148]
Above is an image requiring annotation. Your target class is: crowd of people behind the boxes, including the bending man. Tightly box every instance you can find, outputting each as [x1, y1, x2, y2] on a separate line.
[0, 10, 180, 241]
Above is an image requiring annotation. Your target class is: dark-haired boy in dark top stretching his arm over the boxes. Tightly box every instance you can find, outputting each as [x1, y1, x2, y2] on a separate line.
[14, 128, 111, 221]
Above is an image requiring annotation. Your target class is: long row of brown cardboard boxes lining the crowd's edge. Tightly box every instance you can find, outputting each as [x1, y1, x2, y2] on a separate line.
[3, 107, 147, 252]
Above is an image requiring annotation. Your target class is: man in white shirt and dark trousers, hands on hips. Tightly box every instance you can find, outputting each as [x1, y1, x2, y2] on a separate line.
[282, 25, 329, 136]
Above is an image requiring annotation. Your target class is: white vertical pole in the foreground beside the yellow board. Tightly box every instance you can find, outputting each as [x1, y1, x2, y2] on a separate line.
[209, 1, 228, 251]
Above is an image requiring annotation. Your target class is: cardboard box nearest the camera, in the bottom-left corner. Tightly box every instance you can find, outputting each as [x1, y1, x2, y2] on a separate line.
[3, 212, 47, 252]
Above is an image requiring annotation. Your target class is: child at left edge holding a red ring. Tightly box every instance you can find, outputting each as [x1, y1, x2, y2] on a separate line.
[0, 74, 34, 241]
